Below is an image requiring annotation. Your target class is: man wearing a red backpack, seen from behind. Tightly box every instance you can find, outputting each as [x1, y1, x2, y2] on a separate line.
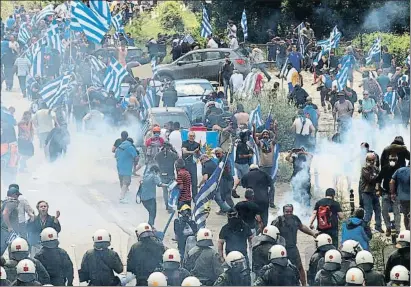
[310, 188, 343, 246]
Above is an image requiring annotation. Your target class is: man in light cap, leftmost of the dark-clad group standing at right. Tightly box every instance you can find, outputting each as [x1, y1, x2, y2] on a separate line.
[360, 153, 384, 233]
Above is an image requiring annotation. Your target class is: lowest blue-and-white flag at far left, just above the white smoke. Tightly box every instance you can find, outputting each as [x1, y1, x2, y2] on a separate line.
[39, 73, 71, 109]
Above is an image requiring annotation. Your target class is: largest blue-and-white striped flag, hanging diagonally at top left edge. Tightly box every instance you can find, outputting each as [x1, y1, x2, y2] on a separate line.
[71, 1, 108, 43]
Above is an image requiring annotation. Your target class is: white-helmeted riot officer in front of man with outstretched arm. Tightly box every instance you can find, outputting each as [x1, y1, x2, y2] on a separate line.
[254, 245, 300, 286]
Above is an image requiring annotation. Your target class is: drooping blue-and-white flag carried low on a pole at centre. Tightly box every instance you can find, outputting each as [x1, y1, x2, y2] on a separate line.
[193, 161, 226, 228]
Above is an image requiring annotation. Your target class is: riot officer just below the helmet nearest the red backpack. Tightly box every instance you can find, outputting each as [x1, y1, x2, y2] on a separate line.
[313, 249, 345, 286]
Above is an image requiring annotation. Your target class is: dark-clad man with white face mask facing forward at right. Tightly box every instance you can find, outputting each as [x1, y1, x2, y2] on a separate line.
[376, 155, 401, 237]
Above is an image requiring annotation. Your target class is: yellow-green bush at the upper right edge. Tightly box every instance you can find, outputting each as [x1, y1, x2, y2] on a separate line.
[353, 32, 410, 65]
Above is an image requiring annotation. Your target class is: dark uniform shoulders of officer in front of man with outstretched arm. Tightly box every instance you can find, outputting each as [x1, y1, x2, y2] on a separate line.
[254, 263, 300, 286]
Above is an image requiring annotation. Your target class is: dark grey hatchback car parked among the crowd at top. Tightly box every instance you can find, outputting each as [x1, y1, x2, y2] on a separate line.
[157, 48, 251, 82]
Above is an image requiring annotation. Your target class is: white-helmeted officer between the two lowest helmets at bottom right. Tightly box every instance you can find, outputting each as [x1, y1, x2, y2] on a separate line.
[355, 250, 385, 286]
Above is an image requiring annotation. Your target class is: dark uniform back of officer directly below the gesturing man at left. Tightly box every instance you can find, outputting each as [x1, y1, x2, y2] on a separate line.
[34, 247, 73, 286]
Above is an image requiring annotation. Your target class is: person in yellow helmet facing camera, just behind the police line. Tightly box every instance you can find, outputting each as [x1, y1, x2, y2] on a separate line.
[174, 204, 197, 258]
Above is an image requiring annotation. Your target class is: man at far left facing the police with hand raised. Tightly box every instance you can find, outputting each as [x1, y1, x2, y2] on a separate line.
[27, 200, 61, 256]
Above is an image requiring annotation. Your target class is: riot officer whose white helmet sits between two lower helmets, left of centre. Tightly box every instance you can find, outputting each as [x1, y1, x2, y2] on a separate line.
[161, 248, 190, 286]
